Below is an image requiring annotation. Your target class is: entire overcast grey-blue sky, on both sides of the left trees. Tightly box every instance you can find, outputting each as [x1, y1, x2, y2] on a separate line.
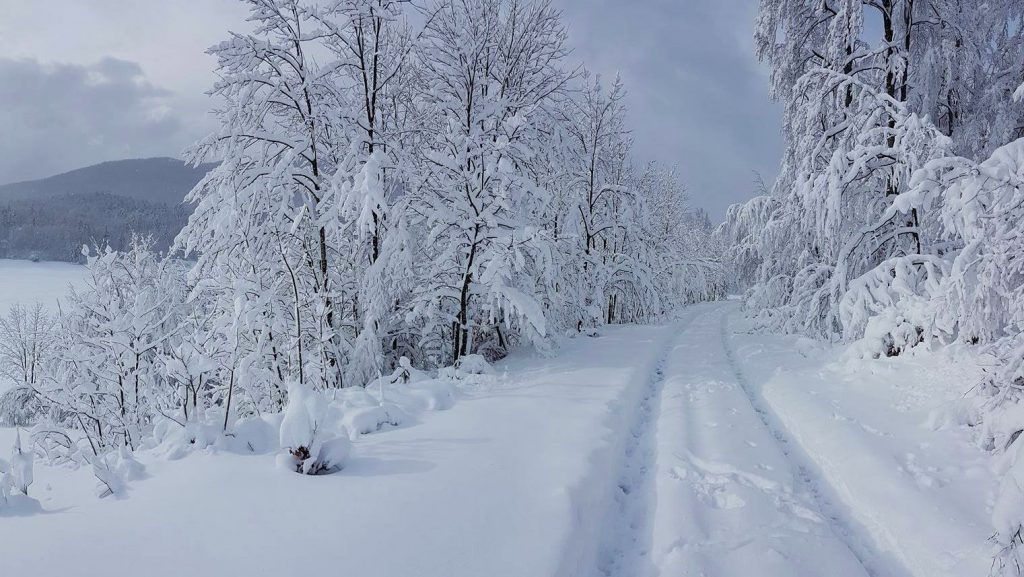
[0, 0, 781, 219]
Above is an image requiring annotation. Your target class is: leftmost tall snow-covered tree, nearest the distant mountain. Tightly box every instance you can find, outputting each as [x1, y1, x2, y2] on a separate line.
[177, 0, 344, 396]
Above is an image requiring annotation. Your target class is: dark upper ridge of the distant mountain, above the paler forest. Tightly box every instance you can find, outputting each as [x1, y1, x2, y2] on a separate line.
[0, 158, 216, 205]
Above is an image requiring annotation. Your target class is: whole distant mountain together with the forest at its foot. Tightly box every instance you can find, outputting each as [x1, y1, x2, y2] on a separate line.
[0, 158, 216, 262]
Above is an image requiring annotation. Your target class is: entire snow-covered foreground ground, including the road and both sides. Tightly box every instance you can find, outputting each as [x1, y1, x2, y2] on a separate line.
[0, 302, 994, 577]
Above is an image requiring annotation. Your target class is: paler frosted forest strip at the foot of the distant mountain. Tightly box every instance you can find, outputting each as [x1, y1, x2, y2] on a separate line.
[0, 192, 191, 262]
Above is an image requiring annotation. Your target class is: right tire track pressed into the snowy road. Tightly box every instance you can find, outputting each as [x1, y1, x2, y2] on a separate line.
[721, 311, 911, 577]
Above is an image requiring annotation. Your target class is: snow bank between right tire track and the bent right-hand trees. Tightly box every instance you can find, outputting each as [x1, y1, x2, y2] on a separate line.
[732, 319, 995, 577]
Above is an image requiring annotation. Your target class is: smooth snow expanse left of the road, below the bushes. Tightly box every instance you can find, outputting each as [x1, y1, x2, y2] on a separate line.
[0, 327, 679, 577]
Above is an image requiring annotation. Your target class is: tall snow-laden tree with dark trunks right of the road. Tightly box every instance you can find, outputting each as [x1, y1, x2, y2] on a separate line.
[730, 0, 1024, 337]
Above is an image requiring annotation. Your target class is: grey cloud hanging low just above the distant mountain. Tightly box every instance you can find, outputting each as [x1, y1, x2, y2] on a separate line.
[0, 57, 194, 183]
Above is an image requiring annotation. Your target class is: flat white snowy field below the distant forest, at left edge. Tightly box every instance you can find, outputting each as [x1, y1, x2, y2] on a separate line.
[0, 258, 86, 315]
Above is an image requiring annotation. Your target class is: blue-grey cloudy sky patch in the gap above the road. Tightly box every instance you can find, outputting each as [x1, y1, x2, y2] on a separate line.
[558, 0, 782, 218]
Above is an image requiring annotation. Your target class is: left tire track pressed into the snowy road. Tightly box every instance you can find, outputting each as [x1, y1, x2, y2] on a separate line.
[597, 311, 709, 577]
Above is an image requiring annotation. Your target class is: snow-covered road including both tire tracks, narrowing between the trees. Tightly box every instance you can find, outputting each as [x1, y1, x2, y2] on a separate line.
[598, 304, 871, 577]
